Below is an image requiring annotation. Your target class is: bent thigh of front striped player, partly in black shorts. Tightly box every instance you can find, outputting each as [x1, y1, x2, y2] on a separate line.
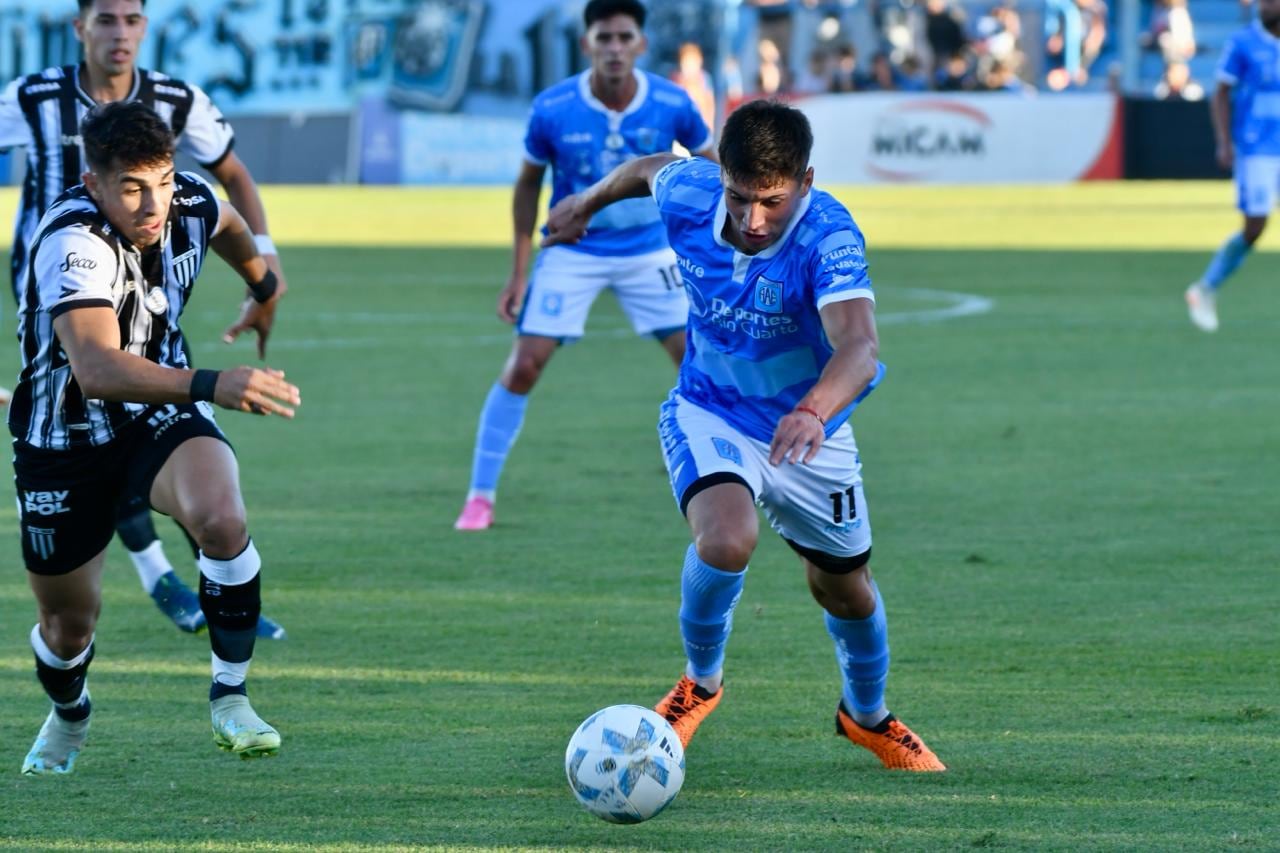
[141, 403, 244, 532]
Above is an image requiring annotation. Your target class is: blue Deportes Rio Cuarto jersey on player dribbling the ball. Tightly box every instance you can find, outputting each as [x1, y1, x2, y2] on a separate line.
[654, 159, 884, 442]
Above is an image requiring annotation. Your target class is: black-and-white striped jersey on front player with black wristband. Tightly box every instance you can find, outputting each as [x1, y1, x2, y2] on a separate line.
[9, 172, 219, 450]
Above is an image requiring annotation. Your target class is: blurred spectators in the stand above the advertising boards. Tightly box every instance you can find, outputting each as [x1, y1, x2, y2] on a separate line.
[655, 0, 1249, 104]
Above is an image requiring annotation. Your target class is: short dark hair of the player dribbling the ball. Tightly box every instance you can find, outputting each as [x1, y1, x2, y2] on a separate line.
[719, 100, 813, 187]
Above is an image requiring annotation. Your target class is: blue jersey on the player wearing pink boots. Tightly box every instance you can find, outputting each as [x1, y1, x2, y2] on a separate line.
[525, 70, 712, 256]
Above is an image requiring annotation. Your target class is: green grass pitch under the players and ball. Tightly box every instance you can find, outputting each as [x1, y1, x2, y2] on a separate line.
[0, 183, 1280, 850]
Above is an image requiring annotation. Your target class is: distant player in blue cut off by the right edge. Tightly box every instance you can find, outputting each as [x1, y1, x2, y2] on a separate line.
[1187, 0, 1280, 332]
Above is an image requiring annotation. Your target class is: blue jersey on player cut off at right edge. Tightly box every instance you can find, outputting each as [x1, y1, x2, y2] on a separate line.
[1217, 22, 1280, 156]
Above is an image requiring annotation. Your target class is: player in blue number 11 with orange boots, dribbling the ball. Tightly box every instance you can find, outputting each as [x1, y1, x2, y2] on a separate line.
[544, 101, 946, 771]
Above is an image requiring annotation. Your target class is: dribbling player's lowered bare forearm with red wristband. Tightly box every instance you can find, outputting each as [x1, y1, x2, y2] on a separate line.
[769, 298, 879, 465]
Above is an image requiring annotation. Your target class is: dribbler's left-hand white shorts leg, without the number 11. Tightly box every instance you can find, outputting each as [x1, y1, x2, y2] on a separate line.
[658, 393, 768, 514]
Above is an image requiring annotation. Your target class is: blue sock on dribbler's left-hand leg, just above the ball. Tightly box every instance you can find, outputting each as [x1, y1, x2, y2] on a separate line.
[680, 546, 746, 680]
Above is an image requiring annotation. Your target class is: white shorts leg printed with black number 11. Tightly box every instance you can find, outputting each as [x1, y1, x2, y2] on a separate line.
[760, 424, 872, 558]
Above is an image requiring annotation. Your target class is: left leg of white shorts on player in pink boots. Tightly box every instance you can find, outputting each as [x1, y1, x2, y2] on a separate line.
[516, 246, 611, 339]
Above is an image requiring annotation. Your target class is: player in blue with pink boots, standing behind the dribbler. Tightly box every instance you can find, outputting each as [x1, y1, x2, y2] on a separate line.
[453, 0, 714, 530]
